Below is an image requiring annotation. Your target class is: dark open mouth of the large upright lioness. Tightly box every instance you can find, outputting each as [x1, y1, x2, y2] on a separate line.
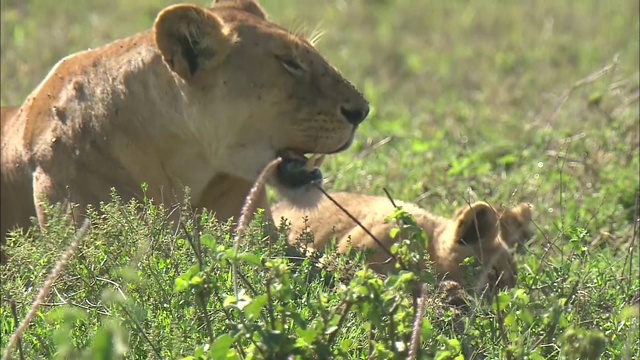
[276, 150, 325, 189]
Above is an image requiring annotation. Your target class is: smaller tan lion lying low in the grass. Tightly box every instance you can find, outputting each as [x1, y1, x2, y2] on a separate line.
[272, 192, 531, 288]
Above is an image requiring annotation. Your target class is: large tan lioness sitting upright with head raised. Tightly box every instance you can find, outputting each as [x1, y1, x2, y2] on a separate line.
[1, 0, 369, 243]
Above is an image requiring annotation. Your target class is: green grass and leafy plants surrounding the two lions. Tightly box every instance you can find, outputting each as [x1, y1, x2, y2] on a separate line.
[0, 0, 640, 359]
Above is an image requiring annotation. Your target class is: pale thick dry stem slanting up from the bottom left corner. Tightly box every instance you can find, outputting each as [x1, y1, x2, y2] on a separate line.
[2, 219, 90, 360]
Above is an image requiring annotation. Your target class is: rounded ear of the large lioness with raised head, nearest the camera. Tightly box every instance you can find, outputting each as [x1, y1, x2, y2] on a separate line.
[153, 5, 235, 81]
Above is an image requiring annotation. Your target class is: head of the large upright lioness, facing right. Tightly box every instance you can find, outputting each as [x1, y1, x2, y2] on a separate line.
[154, 0, 369, 206]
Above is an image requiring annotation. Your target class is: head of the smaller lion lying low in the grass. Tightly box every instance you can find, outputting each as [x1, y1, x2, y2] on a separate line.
[436, 202, 531, 291]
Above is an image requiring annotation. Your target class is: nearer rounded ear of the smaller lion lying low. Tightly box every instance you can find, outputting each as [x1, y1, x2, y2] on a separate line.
[454, 201, 499, 245]
